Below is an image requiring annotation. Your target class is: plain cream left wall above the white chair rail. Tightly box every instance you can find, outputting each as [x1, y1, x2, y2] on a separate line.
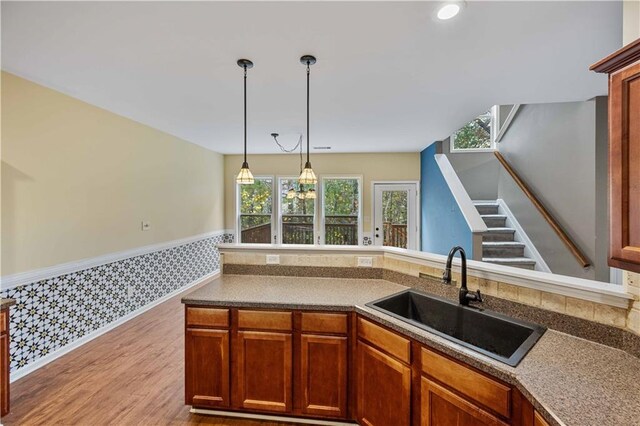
[1, 72, 224, 275]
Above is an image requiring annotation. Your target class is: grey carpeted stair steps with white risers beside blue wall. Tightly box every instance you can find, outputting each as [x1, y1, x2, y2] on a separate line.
[474, 201, 536, 270]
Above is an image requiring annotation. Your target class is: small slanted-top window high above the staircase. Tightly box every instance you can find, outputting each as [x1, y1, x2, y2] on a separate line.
[450, 107, 497, 152]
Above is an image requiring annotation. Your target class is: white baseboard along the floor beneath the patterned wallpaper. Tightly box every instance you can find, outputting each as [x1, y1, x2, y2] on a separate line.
[10, 269, 220, 383]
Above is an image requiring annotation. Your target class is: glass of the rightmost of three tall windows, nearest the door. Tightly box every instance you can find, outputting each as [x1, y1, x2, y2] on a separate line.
[322, 178, 360, 246]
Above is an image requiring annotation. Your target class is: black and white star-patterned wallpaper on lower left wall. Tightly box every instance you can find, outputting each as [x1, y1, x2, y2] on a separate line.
[0, 233, 233, 372]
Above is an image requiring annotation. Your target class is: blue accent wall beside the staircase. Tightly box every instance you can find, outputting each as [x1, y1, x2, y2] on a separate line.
[420, 143, 473, 259]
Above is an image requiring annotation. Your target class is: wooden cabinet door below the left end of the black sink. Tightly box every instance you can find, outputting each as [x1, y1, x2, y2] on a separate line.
[357, 341, 411, 426]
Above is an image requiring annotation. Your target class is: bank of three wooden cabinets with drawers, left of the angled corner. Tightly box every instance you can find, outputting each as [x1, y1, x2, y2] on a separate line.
[185, 306, 350, 419]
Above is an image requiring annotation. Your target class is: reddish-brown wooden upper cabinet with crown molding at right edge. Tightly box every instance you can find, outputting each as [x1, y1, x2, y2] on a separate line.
[590, 39, 640, 272]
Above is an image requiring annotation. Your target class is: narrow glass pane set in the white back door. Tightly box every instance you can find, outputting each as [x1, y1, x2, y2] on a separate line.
[382, 191, 408, 248]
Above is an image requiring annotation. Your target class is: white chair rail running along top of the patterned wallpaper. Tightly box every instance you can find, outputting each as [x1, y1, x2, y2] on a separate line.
[0, 229, 229, 290]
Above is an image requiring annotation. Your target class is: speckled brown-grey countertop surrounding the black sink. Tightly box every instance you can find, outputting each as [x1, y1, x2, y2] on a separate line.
[182, 275, 640, 426]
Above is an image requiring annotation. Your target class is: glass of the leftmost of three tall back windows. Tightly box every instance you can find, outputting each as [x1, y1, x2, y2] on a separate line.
[238, 178, 273, 244]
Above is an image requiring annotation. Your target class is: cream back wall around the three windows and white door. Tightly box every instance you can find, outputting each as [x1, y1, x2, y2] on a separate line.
[224, 152, 420, 232]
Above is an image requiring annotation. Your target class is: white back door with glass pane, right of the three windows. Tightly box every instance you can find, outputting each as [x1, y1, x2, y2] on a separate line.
[373, 183, 418, 250]
